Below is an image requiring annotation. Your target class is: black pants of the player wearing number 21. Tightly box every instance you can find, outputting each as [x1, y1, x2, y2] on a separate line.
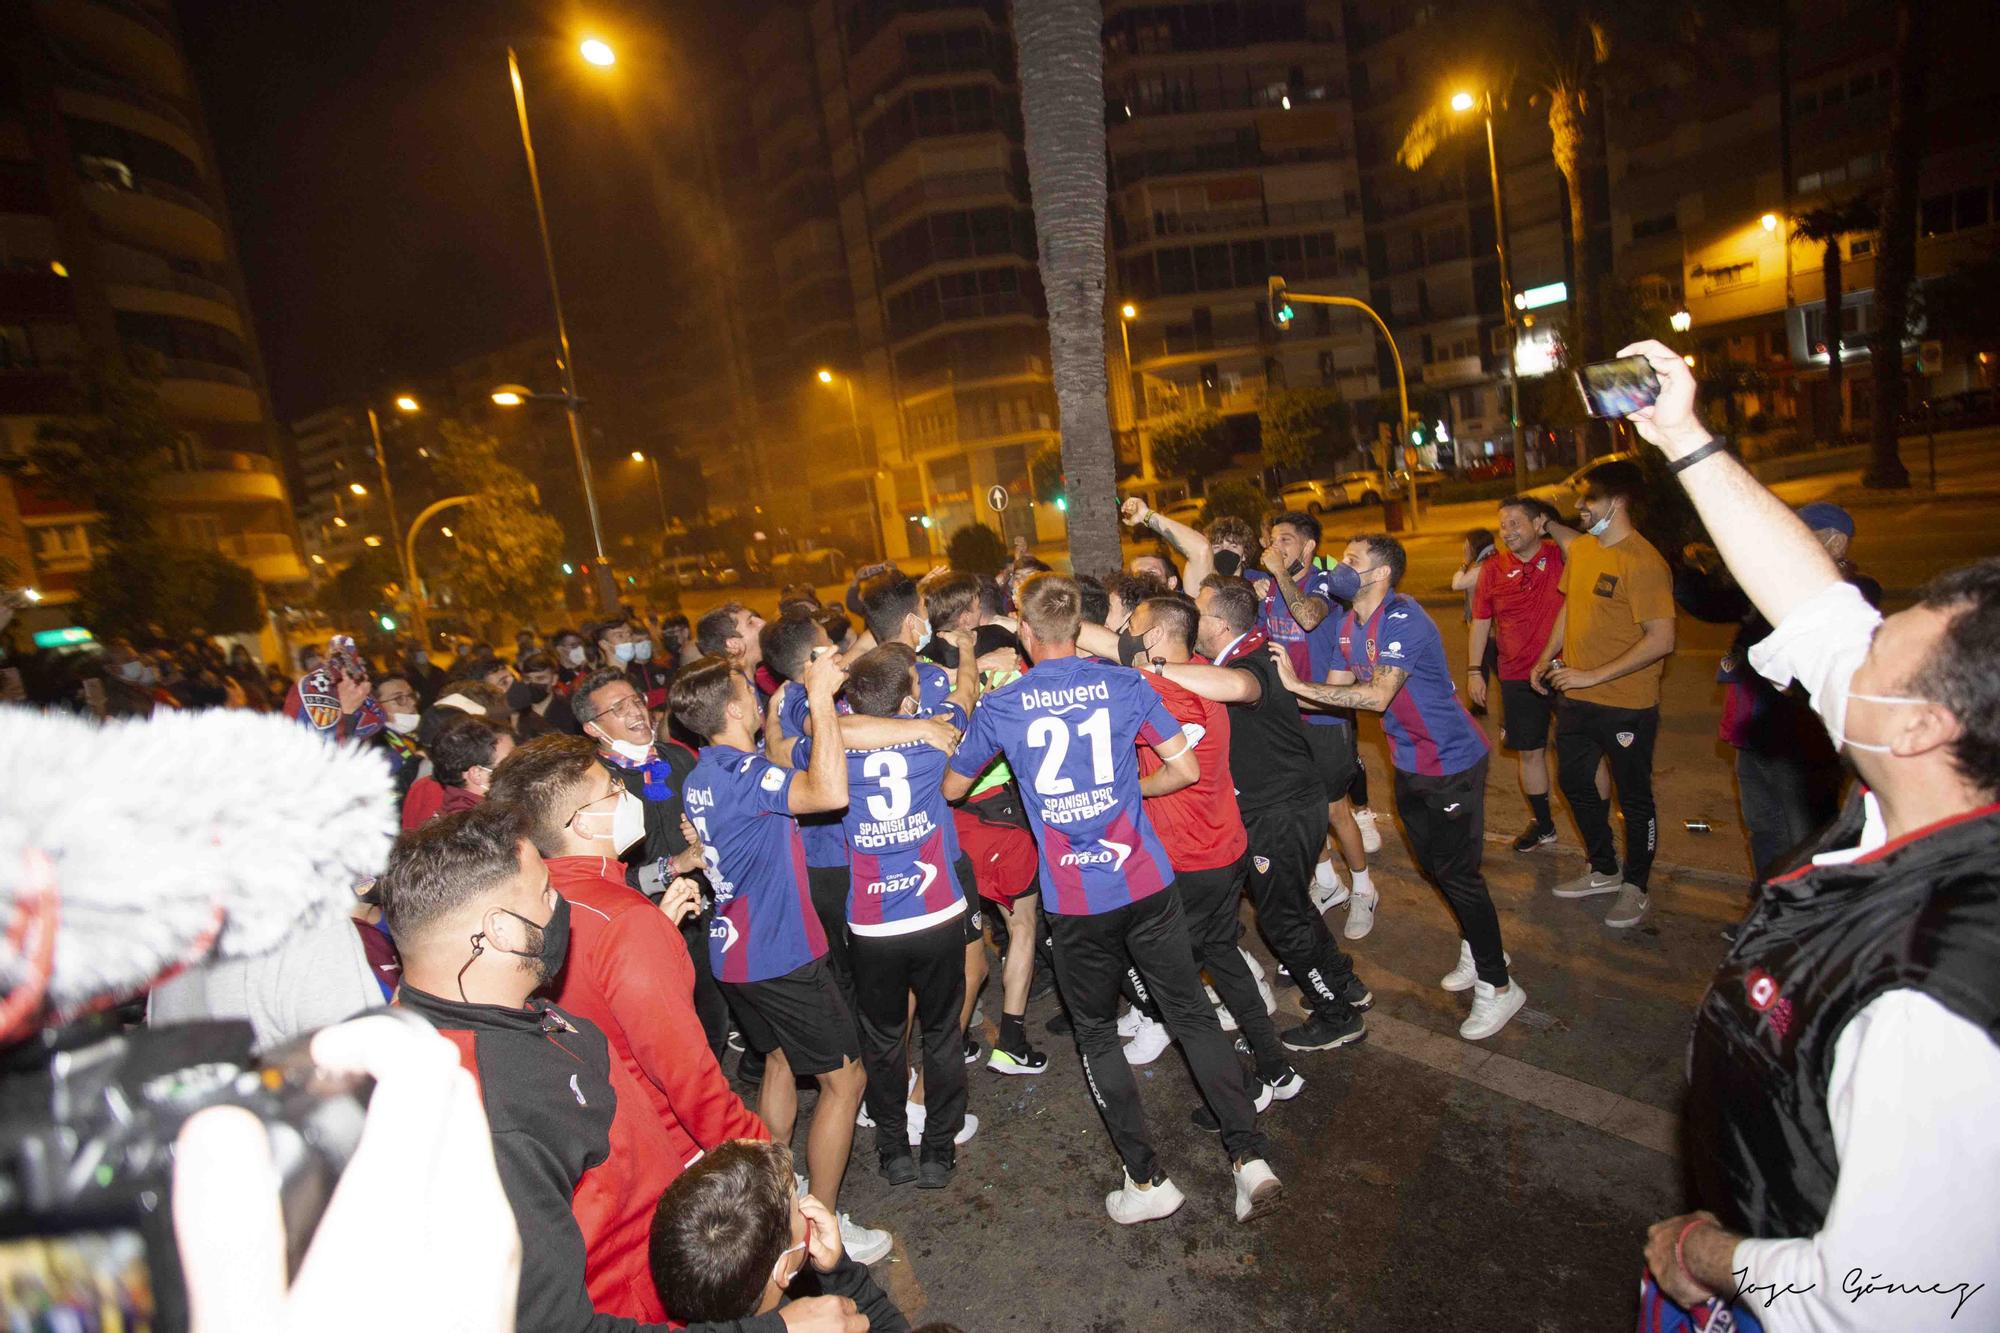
[1048, 885, 1266, 1183]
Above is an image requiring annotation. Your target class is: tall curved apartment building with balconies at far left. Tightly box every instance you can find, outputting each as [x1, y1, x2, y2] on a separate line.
[0, 0, 306, 626]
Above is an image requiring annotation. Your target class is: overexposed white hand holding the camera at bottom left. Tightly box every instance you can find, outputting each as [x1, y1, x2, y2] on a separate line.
[174, 1013, 520, 1333]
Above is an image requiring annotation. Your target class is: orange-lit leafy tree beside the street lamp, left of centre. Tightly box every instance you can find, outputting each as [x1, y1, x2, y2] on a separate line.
[432, 420, 562, 614]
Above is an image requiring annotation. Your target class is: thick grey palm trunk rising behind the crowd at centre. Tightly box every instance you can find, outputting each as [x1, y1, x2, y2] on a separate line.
[1014, 0, 1122, 574]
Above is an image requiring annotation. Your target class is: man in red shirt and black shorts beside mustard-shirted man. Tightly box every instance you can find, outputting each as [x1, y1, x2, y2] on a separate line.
[1466, 494, 1574, 852]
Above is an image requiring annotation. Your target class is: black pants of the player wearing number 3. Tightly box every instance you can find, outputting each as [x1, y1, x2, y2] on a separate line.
[848, 917, 966, 1163]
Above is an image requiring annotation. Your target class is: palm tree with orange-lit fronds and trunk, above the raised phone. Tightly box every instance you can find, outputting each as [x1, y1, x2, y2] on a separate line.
[1396, 0, 1624, 362]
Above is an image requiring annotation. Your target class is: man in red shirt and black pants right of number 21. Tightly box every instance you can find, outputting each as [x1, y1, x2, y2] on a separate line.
[1128, 596, 1306, 1131]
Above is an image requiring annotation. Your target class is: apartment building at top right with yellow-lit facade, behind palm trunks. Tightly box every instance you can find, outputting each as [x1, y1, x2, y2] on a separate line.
[1606, 0, 2000, 438]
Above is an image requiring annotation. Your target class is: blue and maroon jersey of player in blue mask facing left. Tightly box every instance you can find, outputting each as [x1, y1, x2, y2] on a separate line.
[1330, 592, 1486, 777]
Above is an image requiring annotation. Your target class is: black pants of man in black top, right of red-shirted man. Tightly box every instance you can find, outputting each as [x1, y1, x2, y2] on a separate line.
[1230, 787, 1354, 1023]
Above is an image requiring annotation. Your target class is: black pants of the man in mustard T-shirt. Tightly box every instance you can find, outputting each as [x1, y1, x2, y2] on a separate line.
[1556, 699, 1660, 893]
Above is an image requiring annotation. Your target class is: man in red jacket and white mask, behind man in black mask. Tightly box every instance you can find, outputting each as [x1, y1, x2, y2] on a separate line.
[490, 737, 770, 1319]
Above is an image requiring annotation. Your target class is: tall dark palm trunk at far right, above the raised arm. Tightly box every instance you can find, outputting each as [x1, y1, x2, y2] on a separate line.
[1862, 0, 1928, 486]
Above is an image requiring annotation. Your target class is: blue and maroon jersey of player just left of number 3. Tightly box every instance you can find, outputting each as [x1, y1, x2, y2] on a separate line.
[680, 745, 826, 981]
